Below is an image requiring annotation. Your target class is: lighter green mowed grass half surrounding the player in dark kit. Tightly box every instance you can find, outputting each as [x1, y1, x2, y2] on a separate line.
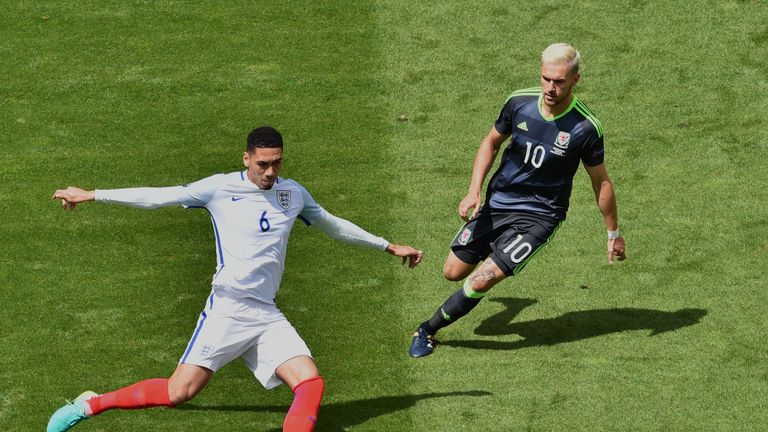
[382, 1, 768, 431]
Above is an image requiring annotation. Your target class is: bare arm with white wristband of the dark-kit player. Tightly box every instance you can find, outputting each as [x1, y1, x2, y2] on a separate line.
[585, 164, 627, 264]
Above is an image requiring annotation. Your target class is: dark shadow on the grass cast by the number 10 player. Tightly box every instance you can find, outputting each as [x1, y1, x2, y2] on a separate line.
[441, 298, 707, 350]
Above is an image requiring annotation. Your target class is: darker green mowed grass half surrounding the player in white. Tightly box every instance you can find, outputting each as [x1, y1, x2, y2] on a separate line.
[0, 2, 400, 431]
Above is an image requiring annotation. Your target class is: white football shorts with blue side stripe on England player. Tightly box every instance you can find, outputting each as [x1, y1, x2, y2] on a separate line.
[179, 287, 312, 390]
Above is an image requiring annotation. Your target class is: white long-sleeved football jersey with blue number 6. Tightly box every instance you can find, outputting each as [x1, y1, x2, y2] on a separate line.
[96, 171, 389, 304]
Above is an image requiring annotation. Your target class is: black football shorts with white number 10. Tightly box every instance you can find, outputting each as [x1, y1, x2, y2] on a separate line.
[451, 208, 562, 276]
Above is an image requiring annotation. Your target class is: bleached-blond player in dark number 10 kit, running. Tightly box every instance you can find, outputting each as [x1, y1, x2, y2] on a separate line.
[409, 43, 626, 357]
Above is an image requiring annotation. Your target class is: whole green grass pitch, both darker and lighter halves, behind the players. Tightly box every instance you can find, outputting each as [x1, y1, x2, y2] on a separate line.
[0, 0, 768, 432]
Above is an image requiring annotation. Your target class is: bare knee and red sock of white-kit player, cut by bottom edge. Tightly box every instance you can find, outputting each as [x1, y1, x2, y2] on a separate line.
[275, 356, 325, 432]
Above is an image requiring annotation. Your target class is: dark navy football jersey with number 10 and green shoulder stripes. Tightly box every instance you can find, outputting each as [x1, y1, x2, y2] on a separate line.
[485, 87, 604, 219]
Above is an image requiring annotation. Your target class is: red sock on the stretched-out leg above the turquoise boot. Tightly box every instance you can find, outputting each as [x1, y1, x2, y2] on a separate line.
[85, 378, 173, 416]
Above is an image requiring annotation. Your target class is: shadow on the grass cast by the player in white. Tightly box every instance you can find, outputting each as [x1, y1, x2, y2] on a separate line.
[176, 390, 492, 432]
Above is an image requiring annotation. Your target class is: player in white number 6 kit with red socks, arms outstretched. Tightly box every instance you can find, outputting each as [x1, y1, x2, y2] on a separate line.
[48, 126, 422, 432]
